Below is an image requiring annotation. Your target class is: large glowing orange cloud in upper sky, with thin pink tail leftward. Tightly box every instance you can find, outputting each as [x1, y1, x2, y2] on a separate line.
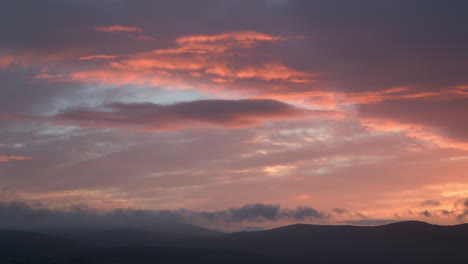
[37, 31, 320, 90]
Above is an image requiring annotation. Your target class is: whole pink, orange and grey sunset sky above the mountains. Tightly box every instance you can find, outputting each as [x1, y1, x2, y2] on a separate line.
[0, 0, 468, 228]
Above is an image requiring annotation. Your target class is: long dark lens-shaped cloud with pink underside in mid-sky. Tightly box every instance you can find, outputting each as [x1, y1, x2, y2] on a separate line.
[51, 99, 333, 130]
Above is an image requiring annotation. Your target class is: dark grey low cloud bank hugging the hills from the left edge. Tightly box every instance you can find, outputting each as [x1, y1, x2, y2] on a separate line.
[0, 201, 329, 229]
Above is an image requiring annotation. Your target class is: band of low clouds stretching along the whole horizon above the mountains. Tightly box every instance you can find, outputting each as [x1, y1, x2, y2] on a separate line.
[0, 199, 468, 231]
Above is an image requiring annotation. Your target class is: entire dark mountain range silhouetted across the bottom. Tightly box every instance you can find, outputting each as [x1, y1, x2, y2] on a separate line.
[0, 221, 468, 264]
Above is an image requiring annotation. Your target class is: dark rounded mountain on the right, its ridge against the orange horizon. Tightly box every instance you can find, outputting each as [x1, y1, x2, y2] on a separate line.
[205, 222, 468, 263]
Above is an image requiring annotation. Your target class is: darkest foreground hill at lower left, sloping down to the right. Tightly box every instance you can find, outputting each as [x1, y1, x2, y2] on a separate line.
[0, 230, 287, 264]
